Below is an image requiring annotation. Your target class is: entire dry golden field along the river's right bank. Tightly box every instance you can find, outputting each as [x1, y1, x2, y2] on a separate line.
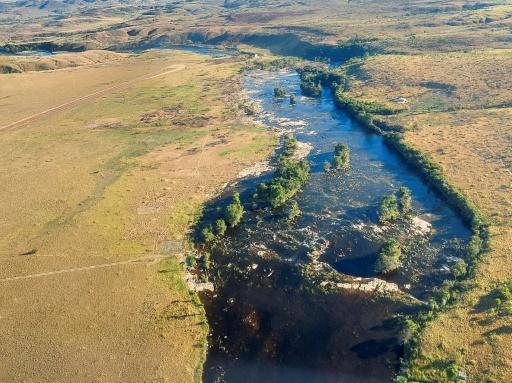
[340, 50, 512, 382]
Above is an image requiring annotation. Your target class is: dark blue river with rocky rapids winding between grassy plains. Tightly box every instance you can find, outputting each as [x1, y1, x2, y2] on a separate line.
[167, 46, 470, 383]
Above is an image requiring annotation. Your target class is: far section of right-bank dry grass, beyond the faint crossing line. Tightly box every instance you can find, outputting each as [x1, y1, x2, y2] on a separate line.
[349, 50, 512, 114]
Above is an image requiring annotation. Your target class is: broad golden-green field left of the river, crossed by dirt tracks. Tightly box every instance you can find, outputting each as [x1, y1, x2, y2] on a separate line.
[0, 52, 273, 382]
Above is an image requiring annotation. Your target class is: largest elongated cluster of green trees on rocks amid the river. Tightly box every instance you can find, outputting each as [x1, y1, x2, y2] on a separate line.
[254, 136, 310, 208]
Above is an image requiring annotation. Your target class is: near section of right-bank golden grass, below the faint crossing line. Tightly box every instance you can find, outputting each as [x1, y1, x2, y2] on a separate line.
[406, 109, 512, 382]
